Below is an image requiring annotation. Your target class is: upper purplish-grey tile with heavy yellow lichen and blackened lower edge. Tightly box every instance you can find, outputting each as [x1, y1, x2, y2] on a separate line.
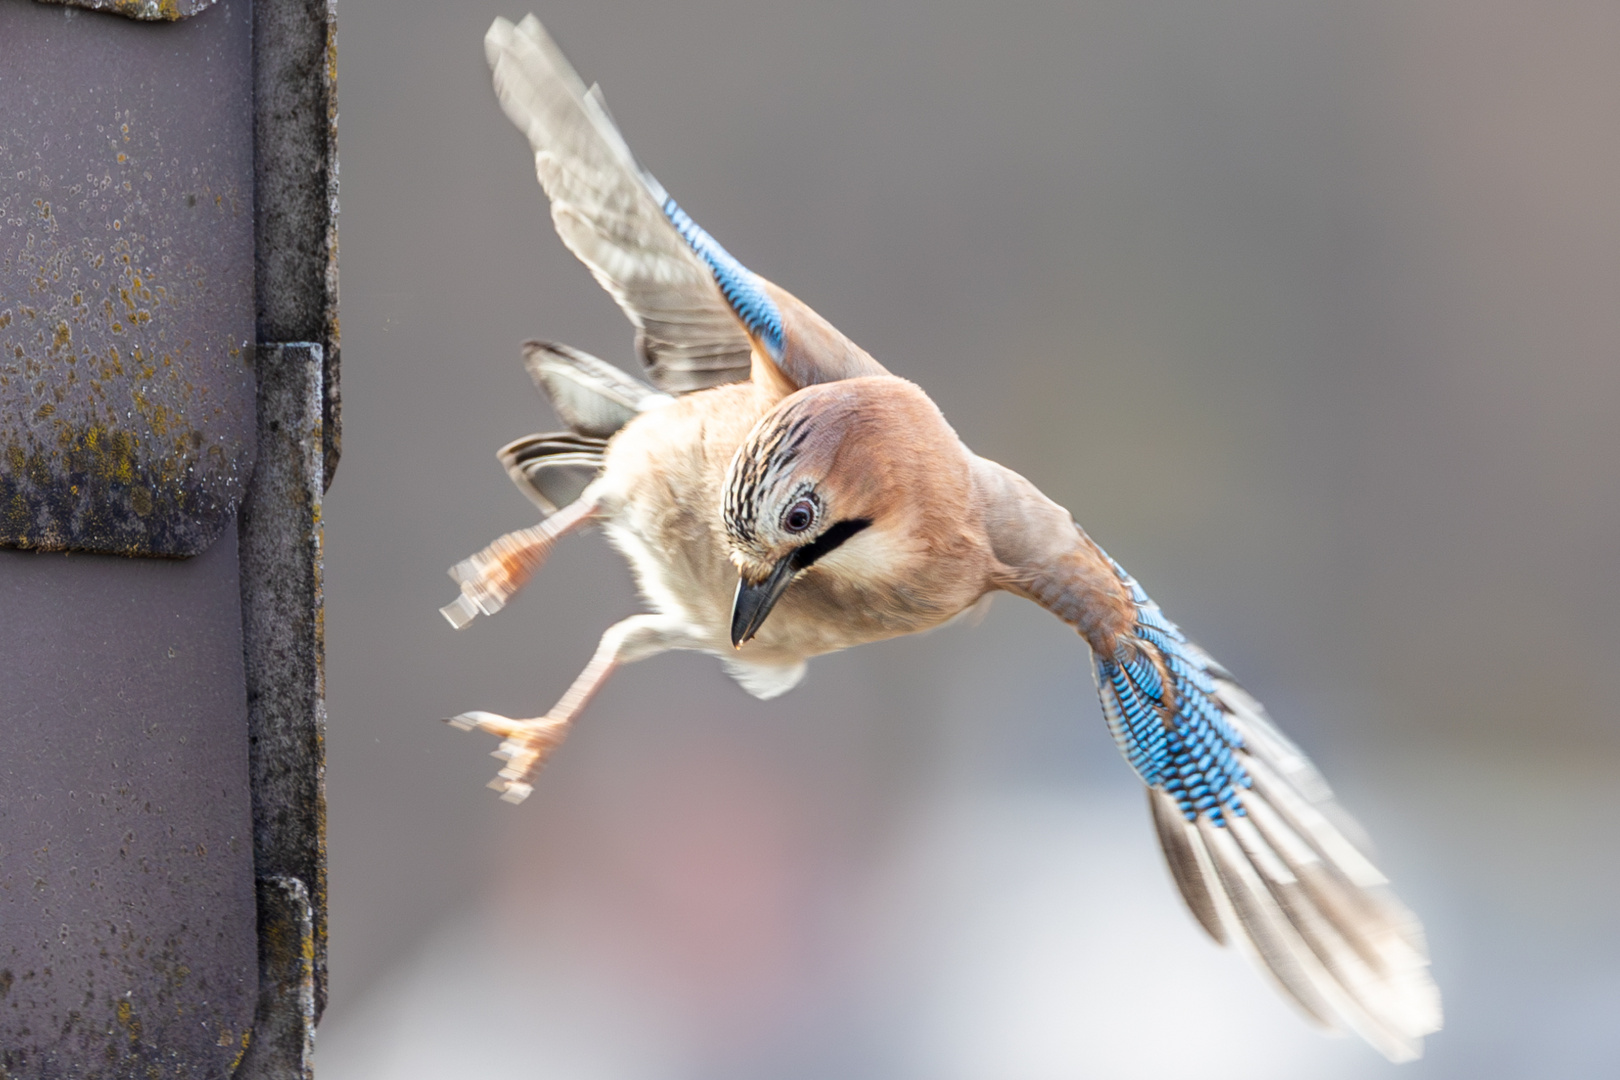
[0, 0, 254, 555]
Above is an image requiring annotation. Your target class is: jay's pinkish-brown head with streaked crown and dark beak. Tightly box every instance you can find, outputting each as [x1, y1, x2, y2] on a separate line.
[723, 376, 966, 648]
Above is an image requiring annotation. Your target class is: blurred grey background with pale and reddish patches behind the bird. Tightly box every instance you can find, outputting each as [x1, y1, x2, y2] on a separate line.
[318, 0, 1620, 1080]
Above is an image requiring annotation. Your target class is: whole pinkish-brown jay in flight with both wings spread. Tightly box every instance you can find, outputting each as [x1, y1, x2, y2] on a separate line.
[442, 16, 1440, 1061]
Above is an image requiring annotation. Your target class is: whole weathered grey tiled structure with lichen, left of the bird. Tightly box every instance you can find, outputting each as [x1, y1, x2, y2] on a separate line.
[0, 0, 337, 1080]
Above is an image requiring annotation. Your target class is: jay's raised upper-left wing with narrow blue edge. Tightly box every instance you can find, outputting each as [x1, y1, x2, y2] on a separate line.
[484, 15, 883, 393]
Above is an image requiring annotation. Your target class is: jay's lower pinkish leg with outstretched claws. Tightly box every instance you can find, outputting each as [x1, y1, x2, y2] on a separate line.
[449, 615, 701, 803]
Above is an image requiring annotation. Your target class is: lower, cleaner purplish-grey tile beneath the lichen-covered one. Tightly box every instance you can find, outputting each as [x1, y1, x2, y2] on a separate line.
[0, 529, 258, 1080]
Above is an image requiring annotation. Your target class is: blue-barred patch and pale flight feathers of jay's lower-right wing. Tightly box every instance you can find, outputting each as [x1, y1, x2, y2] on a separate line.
[1095, 570, 1440, 1061]
